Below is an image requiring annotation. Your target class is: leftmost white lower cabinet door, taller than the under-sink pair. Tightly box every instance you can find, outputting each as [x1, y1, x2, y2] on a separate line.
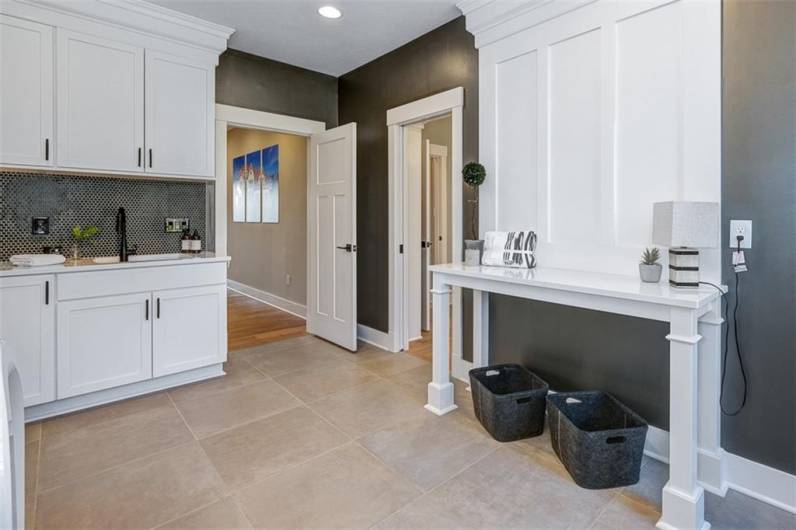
[0, 275, 55, 407]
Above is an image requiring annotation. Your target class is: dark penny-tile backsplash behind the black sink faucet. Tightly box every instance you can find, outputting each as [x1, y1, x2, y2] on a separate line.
[0, 172, 207, 260]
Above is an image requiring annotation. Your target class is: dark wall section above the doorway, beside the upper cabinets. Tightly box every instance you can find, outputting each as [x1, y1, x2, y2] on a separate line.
[216, 50, 337, 127]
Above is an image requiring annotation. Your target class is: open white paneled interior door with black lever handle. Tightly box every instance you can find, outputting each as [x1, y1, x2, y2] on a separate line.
[307, 123, 357, 351]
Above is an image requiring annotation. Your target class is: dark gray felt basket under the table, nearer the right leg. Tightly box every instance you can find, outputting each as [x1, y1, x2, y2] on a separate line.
[547, 392, 647, 489]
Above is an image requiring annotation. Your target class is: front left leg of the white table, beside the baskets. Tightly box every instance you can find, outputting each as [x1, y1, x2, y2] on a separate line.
[426, 274, 456, 416]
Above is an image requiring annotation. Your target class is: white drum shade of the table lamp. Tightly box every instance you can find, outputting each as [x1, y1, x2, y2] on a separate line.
[652, 201, 719, 248]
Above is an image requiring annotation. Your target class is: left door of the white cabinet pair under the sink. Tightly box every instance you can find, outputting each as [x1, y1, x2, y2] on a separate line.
[58, 293, 152, 399]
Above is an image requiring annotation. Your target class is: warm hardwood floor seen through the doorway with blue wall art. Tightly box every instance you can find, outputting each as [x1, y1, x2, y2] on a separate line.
[227, 290, 306, 351]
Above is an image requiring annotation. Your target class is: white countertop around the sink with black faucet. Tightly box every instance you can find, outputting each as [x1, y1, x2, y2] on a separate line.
[0, 252, 231, 278]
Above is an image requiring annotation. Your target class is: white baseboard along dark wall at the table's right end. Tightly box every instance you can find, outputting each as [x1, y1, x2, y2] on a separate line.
[644, 425, 796, 513]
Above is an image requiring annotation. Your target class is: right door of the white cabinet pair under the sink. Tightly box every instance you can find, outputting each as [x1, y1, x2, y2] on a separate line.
[152, 285, 227, 377]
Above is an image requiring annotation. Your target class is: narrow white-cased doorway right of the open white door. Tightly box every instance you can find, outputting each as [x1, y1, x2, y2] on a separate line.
[387, 87, 467, 377]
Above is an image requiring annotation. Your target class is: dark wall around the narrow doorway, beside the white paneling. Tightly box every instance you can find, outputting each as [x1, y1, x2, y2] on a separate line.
[338, 17, 478, 332]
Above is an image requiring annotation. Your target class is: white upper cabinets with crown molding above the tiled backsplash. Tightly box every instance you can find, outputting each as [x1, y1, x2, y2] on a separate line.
[0, 0, 233, 179]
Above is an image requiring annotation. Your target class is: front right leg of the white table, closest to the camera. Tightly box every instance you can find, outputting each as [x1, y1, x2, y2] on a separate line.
[657, 308, 710, 530]
